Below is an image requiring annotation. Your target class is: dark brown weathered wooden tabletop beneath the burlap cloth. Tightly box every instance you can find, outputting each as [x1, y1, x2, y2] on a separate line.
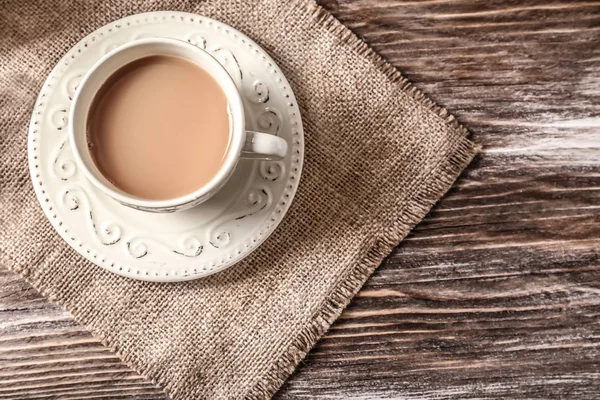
[0, 0, 600, 400]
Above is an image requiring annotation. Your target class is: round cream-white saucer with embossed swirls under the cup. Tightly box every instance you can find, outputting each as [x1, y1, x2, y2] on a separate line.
[28, 12, 304, 281]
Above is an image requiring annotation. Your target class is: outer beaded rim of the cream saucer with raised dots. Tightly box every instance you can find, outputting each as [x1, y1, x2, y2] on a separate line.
[28, 11, 304, 282]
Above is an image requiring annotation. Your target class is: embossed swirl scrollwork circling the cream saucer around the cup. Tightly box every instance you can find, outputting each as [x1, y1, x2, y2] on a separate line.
[52, 27, 285, 259]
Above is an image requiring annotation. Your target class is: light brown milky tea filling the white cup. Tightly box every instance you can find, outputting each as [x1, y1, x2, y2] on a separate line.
[87, 56, 231, 200]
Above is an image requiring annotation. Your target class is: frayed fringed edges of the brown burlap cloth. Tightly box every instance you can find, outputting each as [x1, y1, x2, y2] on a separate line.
[0, 0, 480, 399]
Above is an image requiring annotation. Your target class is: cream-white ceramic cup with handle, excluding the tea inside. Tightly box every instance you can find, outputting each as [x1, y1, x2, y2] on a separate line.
[69, 38, 287, 212]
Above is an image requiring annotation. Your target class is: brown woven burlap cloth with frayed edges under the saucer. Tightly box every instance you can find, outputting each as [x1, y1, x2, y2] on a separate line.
[0, 0, 476, 399]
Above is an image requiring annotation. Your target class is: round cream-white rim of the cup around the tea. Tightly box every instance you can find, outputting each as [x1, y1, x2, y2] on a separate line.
[68, 38, 245, 210]
